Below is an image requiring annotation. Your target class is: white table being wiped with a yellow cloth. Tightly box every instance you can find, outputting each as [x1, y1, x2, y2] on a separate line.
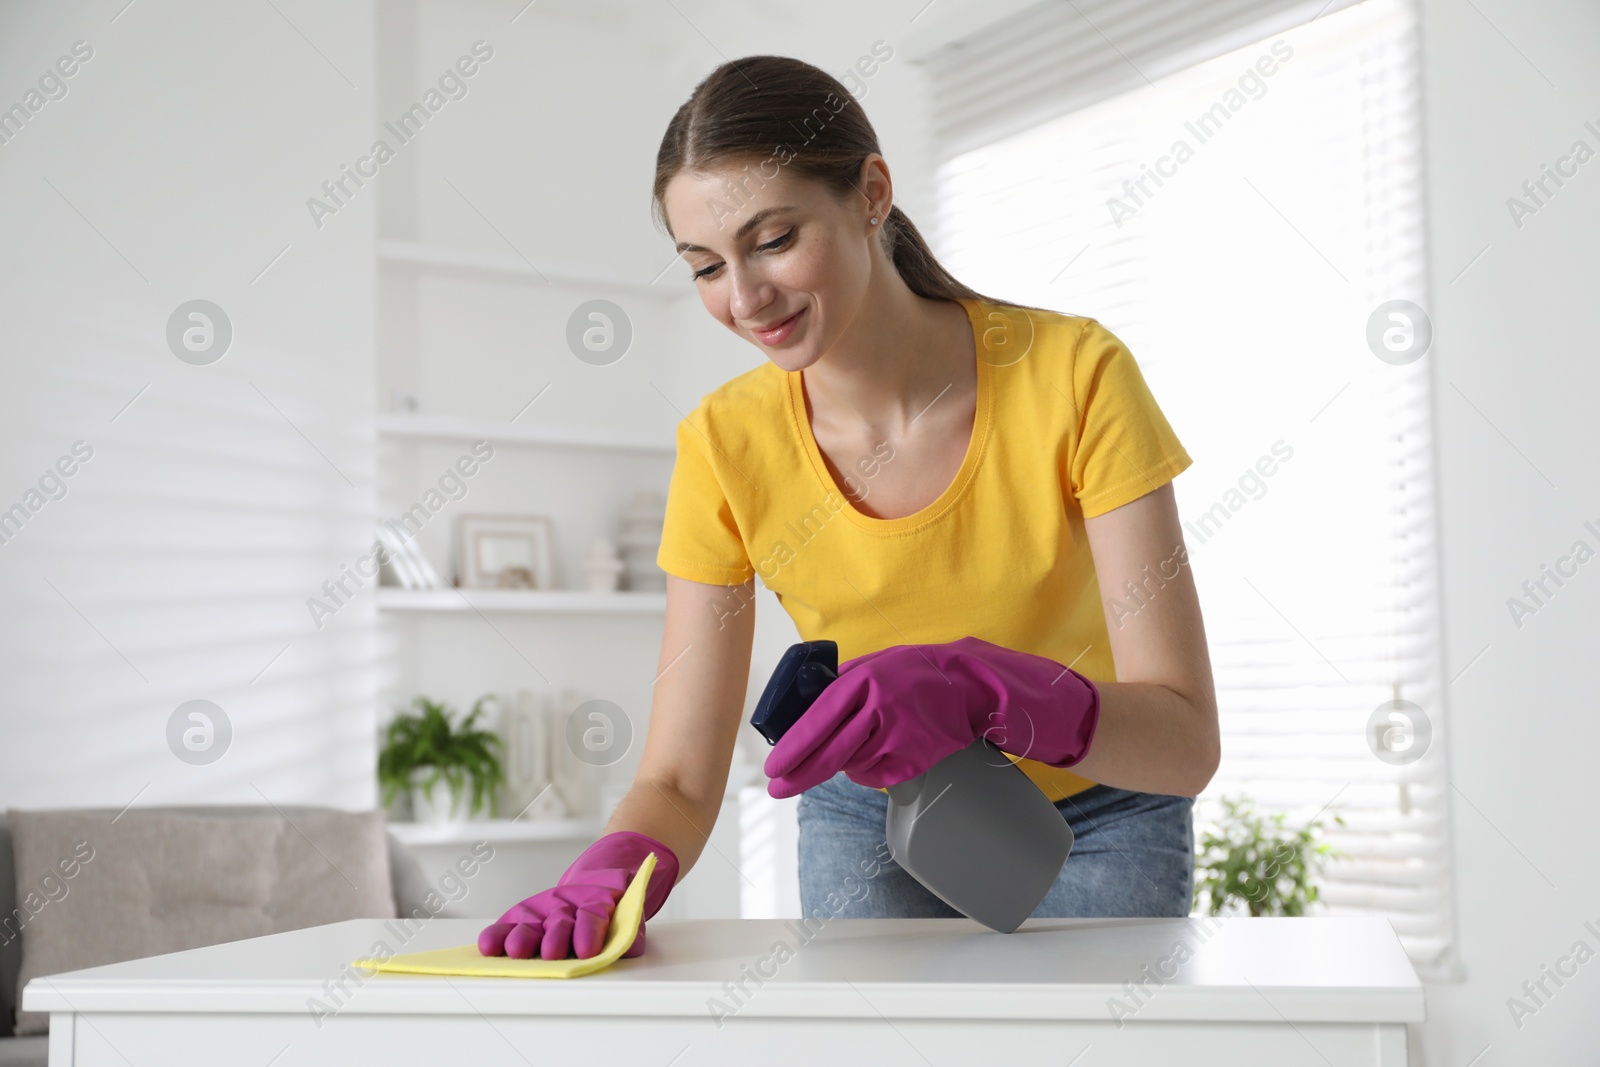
[22, 918, 1424, 1067]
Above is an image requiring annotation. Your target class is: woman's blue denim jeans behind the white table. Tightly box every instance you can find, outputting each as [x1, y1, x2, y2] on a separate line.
[797, 773, 1194, 918]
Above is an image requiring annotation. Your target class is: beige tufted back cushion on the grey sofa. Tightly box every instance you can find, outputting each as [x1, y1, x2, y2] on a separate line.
[6, 808, 395, 1035]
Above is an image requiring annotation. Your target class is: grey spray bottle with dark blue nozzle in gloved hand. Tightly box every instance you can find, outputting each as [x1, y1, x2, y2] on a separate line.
[750, 640, 1072, 934]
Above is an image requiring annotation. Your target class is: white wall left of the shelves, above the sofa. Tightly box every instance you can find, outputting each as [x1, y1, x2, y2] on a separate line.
[0, 0, 374, 806]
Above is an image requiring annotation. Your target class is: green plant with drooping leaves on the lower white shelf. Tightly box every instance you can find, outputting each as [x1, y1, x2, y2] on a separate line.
[378, 693, 506, 816]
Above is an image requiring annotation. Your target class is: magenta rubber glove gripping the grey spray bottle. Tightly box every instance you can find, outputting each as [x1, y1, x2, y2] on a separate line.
[765, 637, 1099, 798]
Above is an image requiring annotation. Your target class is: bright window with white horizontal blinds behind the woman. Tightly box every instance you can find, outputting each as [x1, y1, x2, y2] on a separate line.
[930, 0, 1454, 976]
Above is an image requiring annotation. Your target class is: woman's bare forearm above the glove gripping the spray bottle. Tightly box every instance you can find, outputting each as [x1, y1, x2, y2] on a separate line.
[1072, 681, 1221, 797]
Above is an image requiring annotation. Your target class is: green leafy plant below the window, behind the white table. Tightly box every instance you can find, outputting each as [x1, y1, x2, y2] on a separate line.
[1194, 797, 1344, 915]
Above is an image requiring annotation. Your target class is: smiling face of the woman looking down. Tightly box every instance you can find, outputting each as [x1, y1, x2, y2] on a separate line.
[662, 162, 883, 371]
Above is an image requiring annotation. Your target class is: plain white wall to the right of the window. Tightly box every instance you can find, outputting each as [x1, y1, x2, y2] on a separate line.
[1422, 0, 1600, 1067]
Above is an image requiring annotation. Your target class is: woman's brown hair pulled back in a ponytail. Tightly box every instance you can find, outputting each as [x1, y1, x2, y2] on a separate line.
[651, 56, 1016, 307]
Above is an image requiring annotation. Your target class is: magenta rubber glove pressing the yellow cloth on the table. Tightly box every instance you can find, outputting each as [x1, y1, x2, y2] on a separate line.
[478, 830, 678, 960]
